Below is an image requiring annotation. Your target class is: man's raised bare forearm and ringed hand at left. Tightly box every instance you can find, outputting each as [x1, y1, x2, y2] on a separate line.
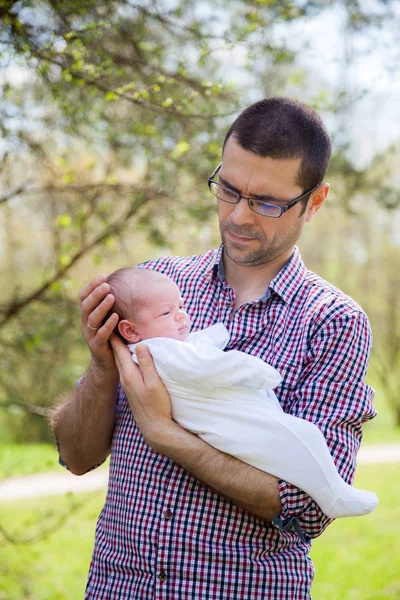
[50, 275, 119, 475]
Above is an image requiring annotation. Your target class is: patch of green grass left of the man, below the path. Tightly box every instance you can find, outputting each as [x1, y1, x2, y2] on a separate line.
[0, 491, 105, 600]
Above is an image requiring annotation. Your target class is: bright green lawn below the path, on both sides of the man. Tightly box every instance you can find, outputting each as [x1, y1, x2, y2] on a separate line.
[0, 464, 400, 600]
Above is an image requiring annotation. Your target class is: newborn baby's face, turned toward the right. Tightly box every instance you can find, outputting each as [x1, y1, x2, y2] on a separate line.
[135, 281, 190, 341]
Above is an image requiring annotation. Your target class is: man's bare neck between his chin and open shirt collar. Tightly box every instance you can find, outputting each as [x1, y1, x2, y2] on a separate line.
[222, 248, 294, 303]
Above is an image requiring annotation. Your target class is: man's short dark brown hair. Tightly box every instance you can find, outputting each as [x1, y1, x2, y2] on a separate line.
[223, 98, 331, 191]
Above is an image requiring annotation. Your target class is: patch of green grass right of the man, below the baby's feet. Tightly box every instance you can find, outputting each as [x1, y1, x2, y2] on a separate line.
[311, 464, 400, 600]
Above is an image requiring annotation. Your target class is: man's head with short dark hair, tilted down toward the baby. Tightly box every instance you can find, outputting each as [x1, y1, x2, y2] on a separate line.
[218, 98, 331, 266]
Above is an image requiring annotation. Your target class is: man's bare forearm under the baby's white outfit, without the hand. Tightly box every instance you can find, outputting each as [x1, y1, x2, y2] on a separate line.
[147, 421, 281, 521]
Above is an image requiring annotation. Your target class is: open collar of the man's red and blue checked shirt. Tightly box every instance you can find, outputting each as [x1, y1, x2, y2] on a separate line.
[207, 244, 307, 303]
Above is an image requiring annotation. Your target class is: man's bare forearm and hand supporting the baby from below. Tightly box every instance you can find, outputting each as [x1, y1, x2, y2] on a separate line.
[111, 336, 281, 521]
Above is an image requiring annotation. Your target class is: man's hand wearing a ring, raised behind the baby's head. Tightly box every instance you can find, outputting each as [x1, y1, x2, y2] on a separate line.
[79, 275, 118, 374]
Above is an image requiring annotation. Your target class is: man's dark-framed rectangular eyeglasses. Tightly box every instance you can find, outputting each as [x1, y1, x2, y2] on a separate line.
[208, 163, 320, 219]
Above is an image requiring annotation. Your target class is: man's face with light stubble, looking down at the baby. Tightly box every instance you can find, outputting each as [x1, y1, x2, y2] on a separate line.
[218, 137, 307, 267]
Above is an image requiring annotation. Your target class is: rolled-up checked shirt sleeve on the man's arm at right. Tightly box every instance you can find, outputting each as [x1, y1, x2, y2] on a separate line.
[275, 310, 377, 538]
